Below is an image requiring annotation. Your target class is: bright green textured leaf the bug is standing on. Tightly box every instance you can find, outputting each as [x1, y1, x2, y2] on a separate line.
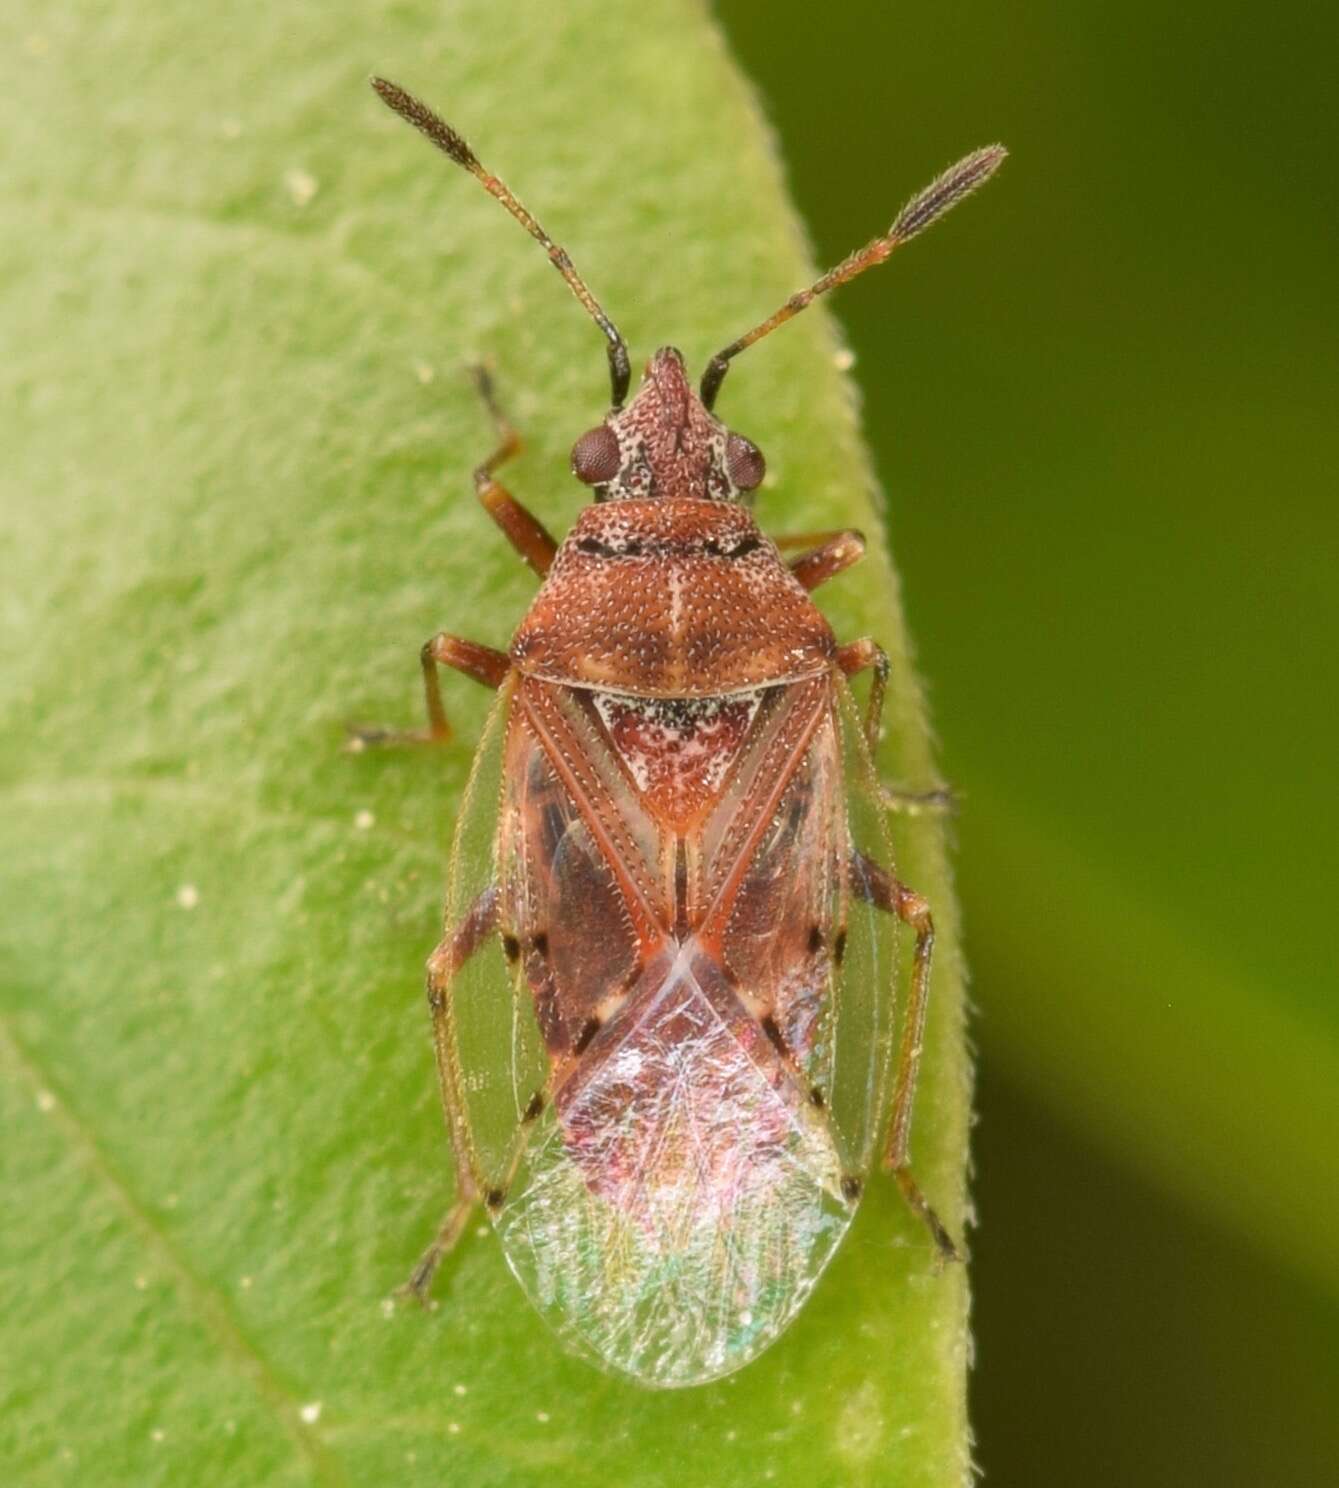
[0, 0, 970, 1488]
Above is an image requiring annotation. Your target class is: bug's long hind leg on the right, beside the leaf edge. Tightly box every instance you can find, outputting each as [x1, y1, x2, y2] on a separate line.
[851, 853, 963, 1260]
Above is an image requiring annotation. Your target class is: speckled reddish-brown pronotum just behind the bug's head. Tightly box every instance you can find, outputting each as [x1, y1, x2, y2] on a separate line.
[512, 497, 836, 698]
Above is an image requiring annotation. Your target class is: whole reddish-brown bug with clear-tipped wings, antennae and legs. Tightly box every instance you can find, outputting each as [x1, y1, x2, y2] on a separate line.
[357, 79, 1004, 1385]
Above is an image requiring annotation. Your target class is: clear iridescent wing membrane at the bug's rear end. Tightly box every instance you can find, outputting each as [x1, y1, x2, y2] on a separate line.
[498, 940, 850, 1385]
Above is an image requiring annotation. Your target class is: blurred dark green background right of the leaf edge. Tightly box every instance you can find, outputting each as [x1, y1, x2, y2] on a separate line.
[719, 0, 1339, 1488]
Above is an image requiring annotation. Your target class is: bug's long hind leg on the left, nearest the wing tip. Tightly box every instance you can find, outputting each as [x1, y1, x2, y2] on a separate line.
[400, 884, 498, 1302]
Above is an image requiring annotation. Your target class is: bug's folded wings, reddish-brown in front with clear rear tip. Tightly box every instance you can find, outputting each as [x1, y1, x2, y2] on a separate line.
[434, 677, 894, 1385]
